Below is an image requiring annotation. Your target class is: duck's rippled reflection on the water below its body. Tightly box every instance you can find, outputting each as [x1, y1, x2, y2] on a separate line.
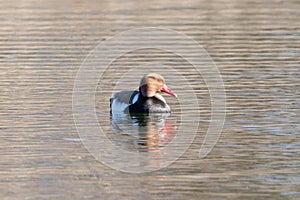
[111, 113, 177, 152]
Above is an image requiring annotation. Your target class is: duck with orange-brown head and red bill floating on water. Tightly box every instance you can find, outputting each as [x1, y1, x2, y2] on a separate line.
[110, 73, 177, 114]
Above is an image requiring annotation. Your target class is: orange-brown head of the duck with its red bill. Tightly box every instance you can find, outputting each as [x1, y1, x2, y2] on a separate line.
[139, 73, 177, 97]
